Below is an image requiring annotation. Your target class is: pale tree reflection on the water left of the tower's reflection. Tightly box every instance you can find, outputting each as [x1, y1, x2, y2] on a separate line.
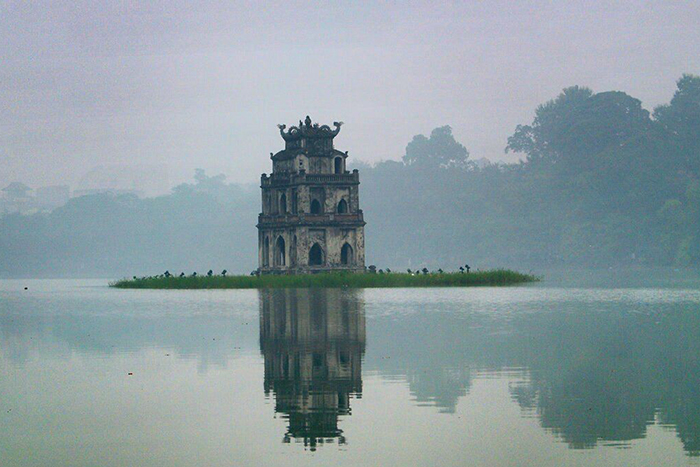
[0, 306, 255, 372]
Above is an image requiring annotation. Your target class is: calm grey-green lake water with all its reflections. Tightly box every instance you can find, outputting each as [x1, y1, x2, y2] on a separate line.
[0, 270, 700, 467]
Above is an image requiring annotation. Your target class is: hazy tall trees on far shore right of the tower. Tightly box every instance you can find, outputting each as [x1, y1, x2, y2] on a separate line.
[362, 75, 700, 267]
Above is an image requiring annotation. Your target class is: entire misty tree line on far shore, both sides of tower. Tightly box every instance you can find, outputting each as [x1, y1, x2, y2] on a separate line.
[0, 75, 700, 277]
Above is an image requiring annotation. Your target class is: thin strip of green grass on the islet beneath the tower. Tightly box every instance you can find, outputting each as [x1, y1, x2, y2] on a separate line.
[110, 269, 539, 289]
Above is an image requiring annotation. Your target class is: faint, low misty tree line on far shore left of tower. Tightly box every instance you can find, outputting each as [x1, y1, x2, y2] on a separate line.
[0, 172, 260, 278]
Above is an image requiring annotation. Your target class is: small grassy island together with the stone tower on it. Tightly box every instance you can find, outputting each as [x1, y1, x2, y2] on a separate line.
[110, 119, 539, 289]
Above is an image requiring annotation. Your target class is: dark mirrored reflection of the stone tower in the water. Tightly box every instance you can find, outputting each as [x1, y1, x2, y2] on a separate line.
[260, 289, 365, 450]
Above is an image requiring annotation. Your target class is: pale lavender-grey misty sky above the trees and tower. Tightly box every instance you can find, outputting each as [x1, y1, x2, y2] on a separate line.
[0, 0, 700, 192]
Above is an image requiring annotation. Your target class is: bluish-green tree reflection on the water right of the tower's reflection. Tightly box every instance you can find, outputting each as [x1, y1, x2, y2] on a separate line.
[366, 302, 700, 455]
